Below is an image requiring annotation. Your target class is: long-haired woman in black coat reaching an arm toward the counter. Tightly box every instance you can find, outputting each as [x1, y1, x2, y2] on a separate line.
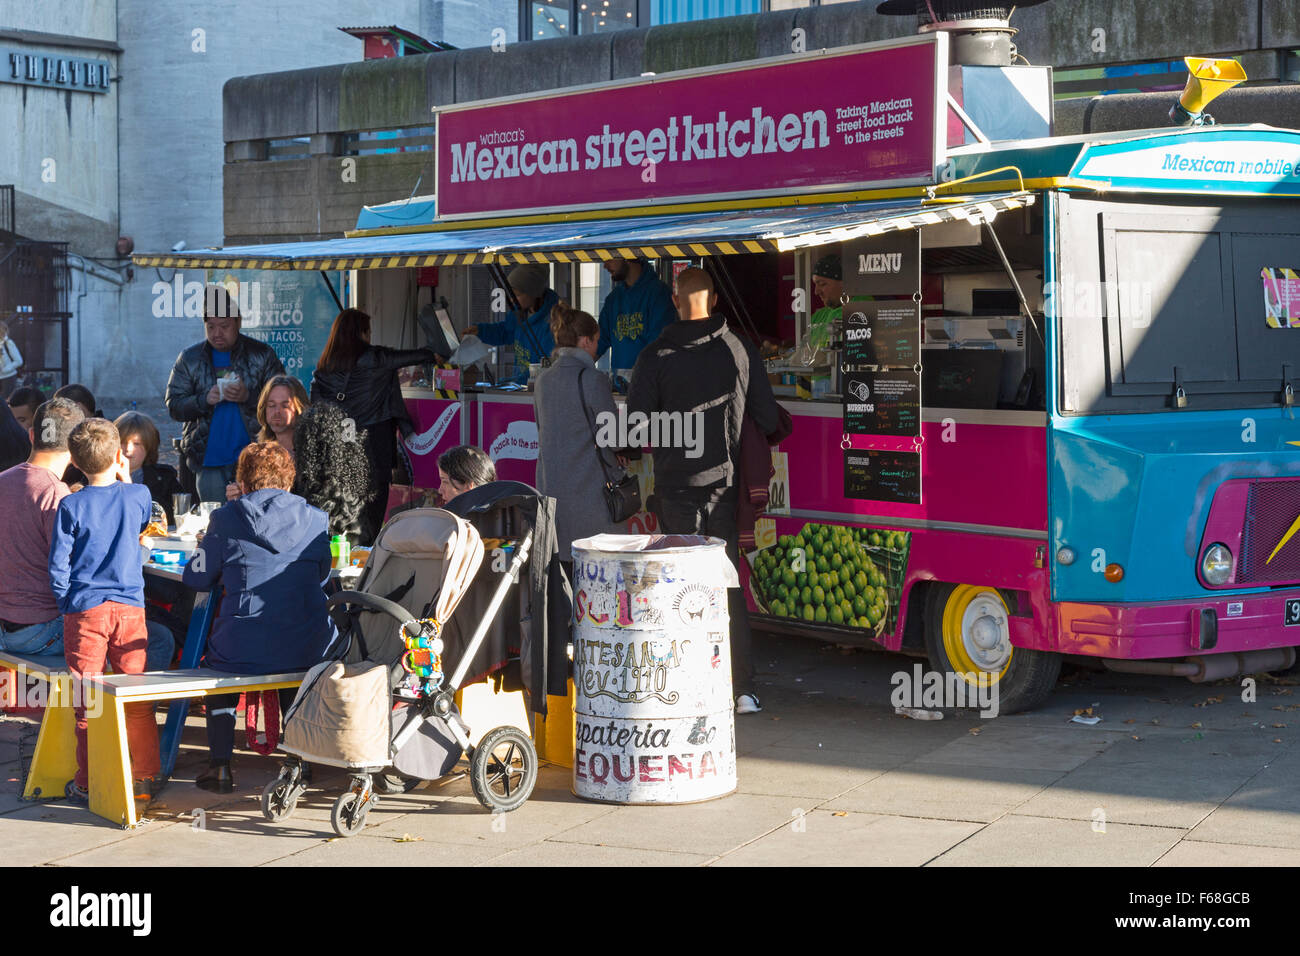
[311, 308, 437, 544]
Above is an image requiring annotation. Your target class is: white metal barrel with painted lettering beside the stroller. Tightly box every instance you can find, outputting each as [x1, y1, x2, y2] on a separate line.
[573, 535, 737, 804]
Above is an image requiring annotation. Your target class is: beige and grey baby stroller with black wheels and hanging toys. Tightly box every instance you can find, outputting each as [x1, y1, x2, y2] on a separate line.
[261, 509, 537, 836]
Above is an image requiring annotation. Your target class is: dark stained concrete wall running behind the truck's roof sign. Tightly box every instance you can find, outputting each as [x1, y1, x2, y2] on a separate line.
[225, 0, 1300, 257]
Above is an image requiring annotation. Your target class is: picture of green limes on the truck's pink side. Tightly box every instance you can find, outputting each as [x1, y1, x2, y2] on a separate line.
[750, 524, 889, 633]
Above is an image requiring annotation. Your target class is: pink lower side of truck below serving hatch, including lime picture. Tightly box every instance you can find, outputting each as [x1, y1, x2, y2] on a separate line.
[404, 389, 1047, 648]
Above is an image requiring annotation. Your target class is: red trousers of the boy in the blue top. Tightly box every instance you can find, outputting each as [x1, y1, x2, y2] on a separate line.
[64, 601, 161, 788]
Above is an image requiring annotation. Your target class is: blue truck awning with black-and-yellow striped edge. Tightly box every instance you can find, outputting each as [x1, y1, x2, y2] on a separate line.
[133, 193, 1035, 271]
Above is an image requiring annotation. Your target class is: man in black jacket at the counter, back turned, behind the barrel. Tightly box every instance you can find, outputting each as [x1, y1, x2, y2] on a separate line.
[628, 268, 780, 714]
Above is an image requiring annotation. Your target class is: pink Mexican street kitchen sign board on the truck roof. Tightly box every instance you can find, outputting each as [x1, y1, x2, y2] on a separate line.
[437, 33, 948, 219]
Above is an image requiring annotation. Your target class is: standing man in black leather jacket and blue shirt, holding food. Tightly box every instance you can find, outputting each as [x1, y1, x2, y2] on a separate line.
[165, 286, 285, 502]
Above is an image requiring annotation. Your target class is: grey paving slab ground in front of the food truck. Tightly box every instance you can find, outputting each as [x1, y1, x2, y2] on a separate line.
[0, 633, 1300, 866]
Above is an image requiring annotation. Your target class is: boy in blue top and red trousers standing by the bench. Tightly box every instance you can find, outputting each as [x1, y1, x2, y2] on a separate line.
[49, 419, 160, 805]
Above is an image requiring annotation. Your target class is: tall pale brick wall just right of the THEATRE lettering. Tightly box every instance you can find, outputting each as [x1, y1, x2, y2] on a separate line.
[108, 0, 425, 408]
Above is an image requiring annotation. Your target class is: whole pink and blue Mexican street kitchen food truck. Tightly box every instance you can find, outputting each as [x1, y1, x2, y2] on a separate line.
[144, 30, 1300, 711]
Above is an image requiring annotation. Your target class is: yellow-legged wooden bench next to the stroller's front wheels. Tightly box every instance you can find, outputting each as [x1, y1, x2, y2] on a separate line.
[89, 667, 306, 829]
